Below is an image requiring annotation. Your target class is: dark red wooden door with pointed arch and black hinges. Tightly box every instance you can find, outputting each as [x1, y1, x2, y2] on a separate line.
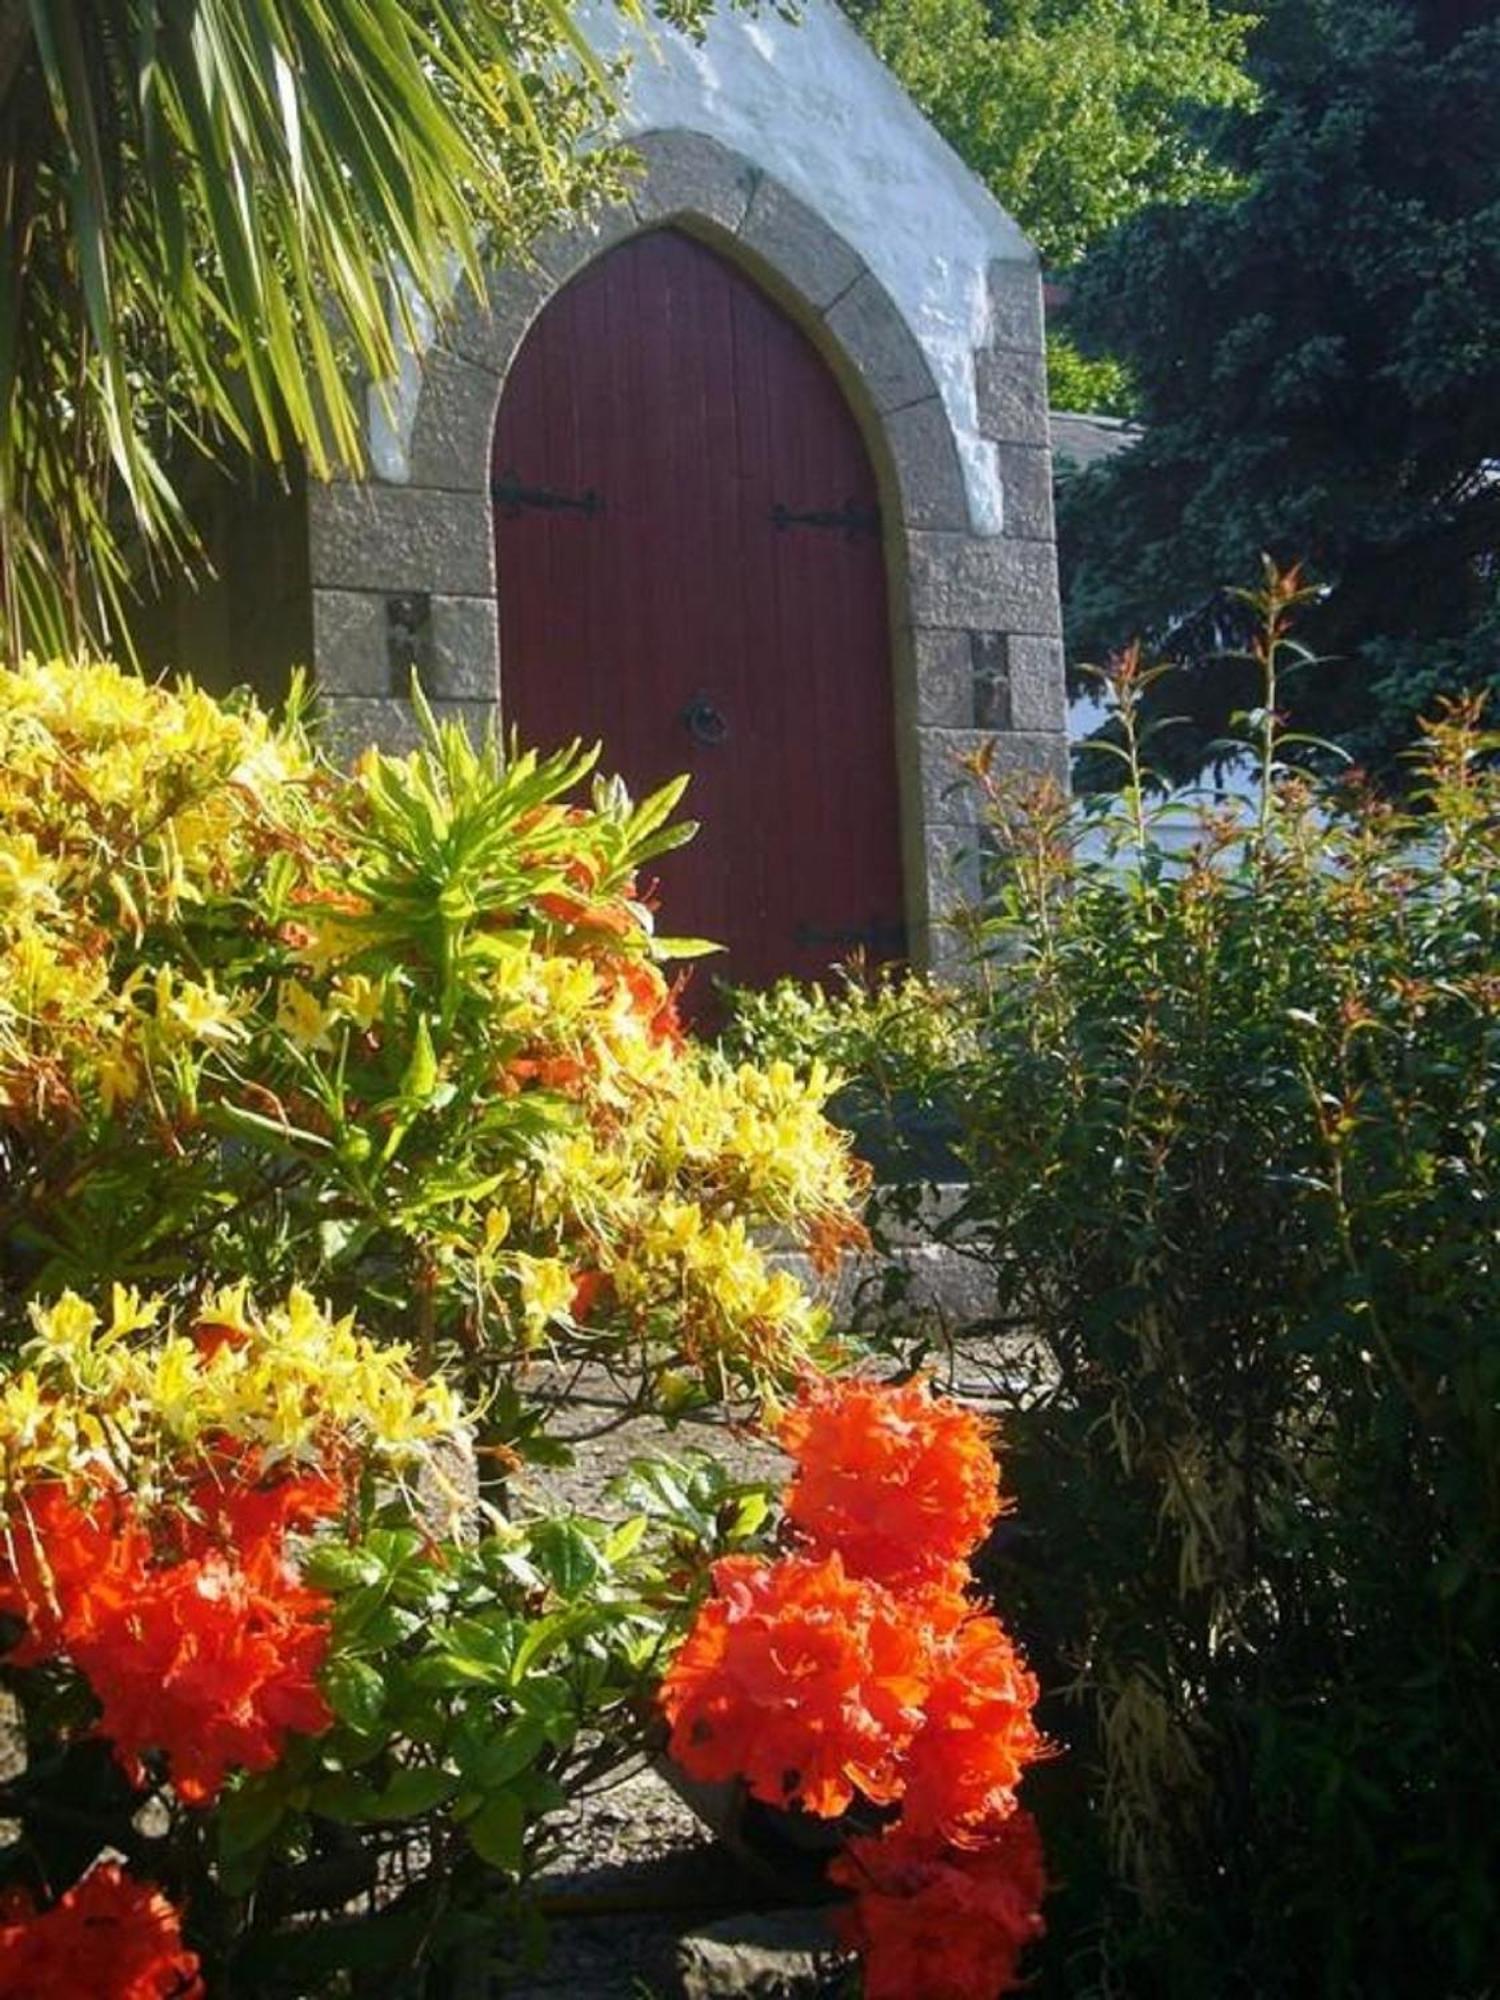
[494, 230, 904, 982]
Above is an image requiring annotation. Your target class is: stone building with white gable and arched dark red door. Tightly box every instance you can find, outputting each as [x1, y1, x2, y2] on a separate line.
[141, 0, 1066, 978]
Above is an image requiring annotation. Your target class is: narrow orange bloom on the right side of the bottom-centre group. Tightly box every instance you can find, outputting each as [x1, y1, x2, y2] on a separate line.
[902, 1614, 1046, 1846]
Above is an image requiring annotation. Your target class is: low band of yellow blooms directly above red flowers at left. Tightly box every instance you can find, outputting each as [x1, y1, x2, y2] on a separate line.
[0, 1286, 462, 1490]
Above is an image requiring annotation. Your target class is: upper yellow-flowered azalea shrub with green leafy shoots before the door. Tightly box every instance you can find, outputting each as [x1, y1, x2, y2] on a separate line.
[0, 664, 864, 1396]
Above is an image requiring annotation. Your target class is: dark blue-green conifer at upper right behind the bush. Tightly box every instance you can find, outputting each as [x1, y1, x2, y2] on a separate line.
[1060, 0, 1500, 774]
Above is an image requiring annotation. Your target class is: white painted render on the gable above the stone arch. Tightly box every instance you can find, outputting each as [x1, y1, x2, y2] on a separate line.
[368, 0, 1036, 534]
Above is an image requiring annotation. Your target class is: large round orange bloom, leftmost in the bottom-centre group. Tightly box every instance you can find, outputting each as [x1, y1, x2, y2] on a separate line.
[660, 1556, 930, 1818]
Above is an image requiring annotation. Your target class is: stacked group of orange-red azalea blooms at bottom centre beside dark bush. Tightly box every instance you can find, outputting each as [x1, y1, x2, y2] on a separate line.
[660, 1380, 1044, 2000]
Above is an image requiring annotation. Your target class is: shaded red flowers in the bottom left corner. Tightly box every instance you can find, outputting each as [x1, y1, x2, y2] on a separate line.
[0, 1862, 204, 2000]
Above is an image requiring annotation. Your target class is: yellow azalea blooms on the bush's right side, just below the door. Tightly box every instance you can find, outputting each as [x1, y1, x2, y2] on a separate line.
[374, 932, 866, 1378]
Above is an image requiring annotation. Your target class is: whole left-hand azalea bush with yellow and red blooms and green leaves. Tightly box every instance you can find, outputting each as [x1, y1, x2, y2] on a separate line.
[0, 662, 864, 1994]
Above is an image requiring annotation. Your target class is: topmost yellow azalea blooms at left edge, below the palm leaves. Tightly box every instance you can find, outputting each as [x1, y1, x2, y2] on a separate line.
[0, 660, 312, 1124]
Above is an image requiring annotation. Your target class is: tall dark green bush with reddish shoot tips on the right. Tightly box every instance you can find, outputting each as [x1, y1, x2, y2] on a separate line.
[952, 574, 1500, 2000]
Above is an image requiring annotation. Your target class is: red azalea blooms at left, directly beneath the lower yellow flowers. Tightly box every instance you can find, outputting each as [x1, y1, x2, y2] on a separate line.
[0, 1466, 342, 1806]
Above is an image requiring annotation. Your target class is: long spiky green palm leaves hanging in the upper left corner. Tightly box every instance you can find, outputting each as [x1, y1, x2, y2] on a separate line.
[0, 0, 682, 652]
